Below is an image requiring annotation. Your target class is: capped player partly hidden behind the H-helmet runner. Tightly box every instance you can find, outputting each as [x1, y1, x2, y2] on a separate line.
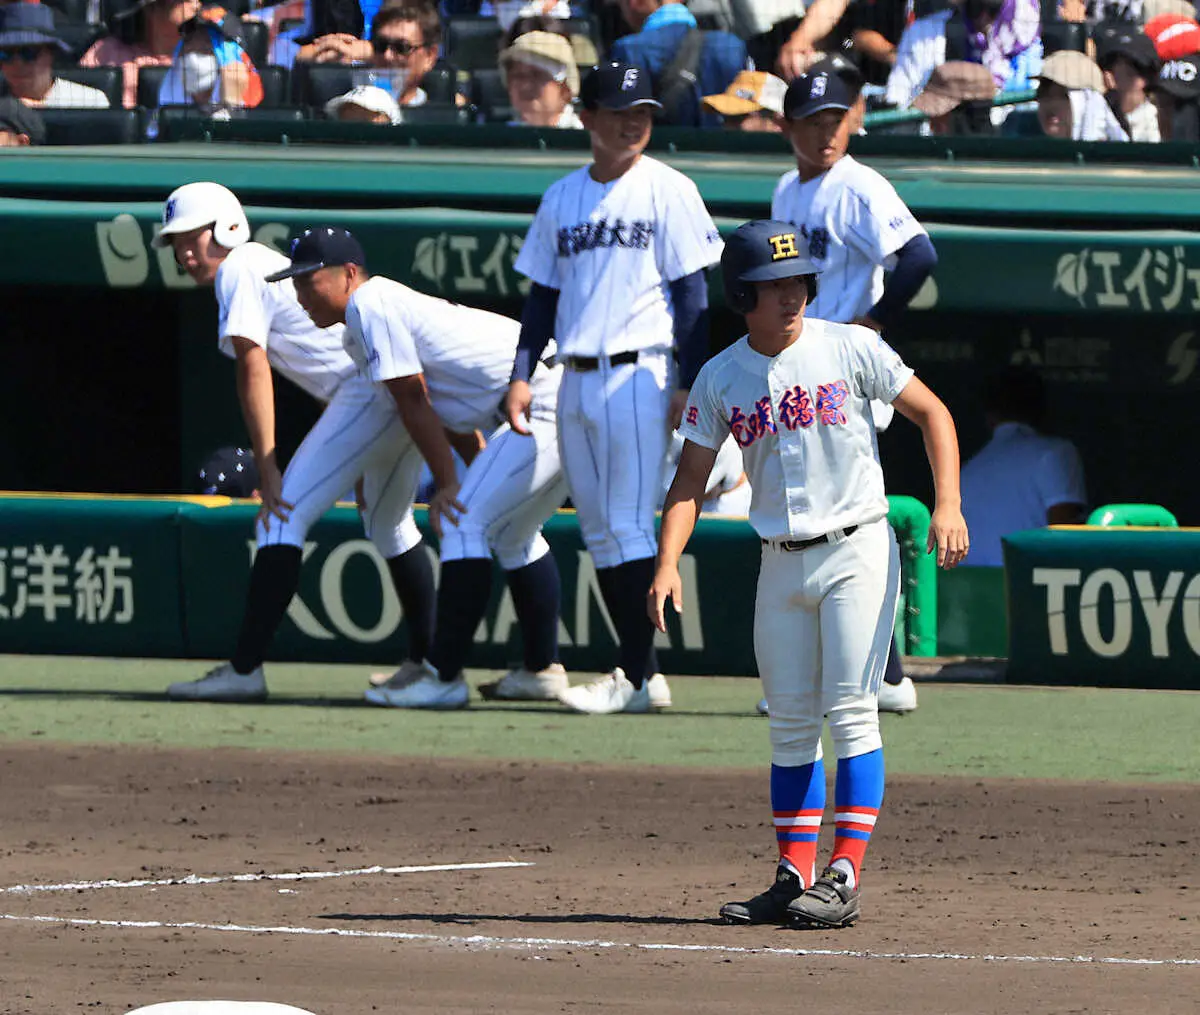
[770, 60, 937, 711]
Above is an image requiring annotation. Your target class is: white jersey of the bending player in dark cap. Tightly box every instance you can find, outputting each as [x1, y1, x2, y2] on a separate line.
[346, 276, 558, 433]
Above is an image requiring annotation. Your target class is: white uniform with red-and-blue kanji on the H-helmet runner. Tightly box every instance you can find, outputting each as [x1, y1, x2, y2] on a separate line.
[680, 318, 913, 765]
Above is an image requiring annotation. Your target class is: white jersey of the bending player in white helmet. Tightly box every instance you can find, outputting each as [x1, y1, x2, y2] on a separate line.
[216, 244, 358, 402]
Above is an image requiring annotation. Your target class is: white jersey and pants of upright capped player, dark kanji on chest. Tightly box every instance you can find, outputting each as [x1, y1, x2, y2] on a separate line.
[516, 156, 722, 567]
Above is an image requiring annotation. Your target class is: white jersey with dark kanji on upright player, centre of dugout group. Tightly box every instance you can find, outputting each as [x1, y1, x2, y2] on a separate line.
[516, 155, 722, 356]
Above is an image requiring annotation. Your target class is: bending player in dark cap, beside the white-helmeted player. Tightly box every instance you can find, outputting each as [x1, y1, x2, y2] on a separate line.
[271, 226, 568, 708]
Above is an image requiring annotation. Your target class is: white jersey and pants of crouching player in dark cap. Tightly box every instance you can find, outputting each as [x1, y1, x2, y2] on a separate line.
[346, 276, 566, 571]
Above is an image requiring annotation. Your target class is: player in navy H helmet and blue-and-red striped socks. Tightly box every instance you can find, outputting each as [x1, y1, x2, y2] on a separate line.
[648, 221, 967, 927]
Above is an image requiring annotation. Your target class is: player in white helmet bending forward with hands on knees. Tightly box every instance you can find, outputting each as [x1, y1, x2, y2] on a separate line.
[154, 182, 434, 702]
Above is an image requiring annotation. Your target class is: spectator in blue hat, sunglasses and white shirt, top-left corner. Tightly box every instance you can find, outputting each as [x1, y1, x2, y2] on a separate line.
[0, 4, 108, 109]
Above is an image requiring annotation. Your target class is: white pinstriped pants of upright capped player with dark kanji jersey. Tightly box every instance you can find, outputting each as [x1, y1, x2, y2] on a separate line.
[558, 349, 673, 567]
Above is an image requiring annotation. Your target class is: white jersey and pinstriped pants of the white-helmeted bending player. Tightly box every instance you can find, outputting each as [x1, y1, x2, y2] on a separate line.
[216, 242, 421, 558]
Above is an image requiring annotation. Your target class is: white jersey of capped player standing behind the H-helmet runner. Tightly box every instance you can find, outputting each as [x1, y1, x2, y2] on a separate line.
[770, 155, 925, 323]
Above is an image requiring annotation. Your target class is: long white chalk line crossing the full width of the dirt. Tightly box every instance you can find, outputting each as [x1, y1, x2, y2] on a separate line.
[0, 913, 1200, 966]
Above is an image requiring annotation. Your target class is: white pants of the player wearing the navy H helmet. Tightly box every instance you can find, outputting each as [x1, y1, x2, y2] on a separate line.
[754, 518, 900, 767]
